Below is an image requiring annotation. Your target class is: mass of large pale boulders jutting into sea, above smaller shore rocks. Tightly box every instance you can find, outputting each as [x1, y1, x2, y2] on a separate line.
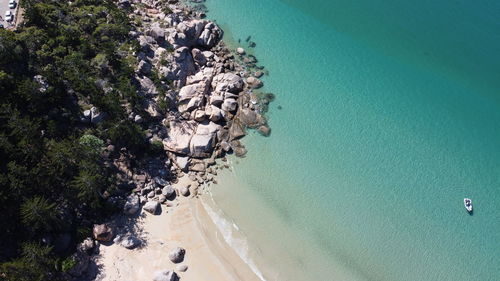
[122, 0, 270, 179]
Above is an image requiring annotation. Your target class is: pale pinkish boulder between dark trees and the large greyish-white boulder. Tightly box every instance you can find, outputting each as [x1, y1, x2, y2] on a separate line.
[163, 121, 197, 155]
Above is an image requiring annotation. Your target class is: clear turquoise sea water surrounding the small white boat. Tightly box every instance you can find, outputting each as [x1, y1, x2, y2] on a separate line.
[202, 0, 500, 281]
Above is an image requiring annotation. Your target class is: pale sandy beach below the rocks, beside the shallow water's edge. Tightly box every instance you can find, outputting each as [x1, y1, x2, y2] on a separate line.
[97, 176, 259, 281]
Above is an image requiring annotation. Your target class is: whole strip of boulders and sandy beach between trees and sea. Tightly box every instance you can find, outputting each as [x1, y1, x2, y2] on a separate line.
[93, 0, 274, 281]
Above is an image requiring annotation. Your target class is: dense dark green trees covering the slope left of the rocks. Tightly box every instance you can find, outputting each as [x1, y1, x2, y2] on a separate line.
[0, 0, 147, 280]
